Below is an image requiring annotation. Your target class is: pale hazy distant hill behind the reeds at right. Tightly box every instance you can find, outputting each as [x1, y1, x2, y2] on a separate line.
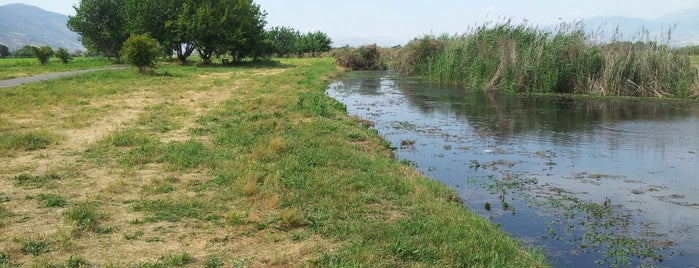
[582, 9, 699, 46]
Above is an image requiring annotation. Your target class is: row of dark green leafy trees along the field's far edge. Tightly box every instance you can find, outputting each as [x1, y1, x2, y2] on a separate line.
[68, 0, 330, 63]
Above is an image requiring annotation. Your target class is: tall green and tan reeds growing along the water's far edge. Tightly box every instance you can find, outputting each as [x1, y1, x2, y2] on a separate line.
[391, 22, 699, 98]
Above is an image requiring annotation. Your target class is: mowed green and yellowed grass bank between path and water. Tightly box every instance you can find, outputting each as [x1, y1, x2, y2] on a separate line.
[0, 59, 545, 267]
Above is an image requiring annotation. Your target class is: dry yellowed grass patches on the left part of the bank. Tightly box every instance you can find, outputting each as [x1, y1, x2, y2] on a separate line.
[0, 62, 337, 266]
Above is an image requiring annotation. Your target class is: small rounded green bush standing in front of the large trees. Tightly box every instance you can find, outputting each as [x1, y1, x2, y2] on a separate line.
[121, 34, 160, 74]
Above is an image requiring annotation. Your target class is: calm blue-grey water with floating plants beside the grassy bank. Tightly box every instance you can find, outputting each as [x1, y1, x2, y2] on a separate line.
[327, 72, 699, 267]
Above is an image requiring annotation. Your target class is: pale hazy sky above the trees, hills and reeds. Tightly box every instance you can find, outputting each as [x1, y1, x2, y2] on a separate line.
[0, 0, 699, 46]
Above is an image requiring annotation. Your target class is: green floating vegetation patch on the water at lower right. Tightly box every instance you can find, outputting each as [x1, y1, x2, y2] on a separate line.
[470, 171, 680, 267]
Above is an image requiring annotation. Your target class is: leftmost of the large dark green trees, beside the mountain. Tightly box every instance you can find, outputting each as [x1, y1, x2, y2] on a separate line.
[68, 0, 129, 61]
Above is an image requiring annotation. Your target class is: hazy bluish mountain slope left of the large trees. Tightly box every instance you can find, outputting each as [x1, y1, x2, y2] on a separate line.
[0, 4, 85, 52]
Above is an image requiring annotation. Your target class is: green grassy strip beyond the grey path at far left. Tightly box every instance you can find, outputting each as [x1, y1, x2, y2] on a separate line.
[0, 57, 113, 80]
